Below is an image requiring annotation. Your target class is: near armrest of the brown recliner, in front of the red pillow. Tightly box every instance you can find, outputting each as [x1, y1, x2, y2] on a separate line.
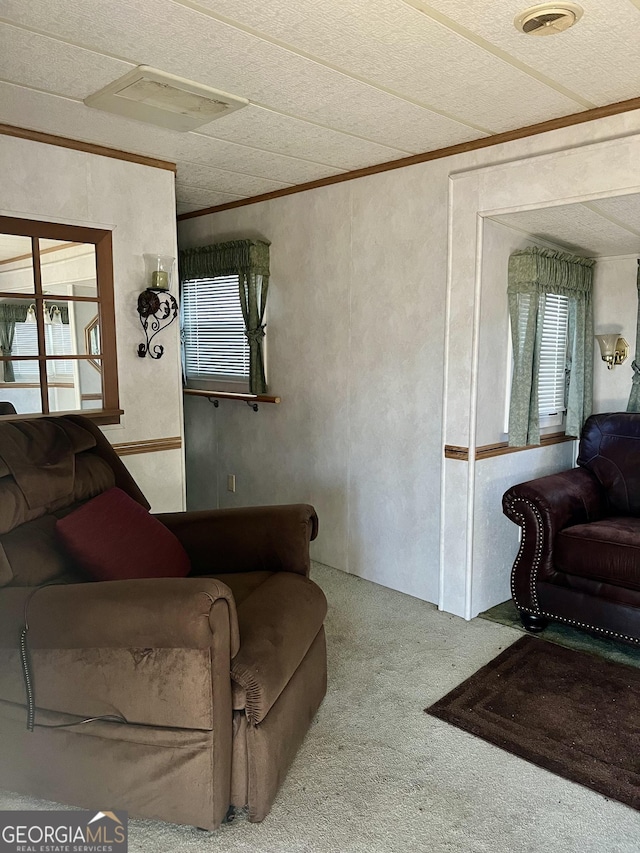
[0, 578, 240, 655]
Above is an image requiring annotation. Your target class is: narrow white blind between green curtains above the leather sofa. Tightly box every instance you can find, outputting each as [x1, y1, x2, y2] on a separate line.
[538, 293, 569, 425]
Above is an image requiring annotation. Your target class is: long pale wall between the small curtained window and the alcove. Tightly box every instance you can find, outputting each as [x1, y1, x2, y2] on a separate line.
[185, 170, 446, 600]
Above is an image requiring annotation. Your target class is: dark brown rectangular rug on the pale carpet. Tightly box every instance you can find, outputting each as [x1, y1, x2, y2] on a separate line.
[425, 636, 640, 809]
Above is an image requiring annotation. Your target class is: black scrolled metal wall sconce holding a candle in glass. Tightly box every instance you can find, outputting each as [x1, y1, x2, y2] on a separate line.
[138, 255, 178, 358]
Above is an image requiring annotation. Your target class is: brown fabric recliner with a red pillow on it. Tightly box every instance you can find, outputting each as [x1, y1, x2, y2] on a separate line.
[0, 416, 326, 829]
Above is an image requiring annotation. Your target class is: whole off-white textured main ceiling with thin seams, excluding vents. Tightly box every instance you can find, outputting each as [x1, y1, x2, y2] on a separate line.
[0, 0, 640, 218]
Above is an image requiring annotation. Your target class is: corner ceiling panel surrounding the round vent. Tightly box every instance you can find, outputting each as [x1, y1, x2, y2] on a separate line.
[420, 0, 640, 104]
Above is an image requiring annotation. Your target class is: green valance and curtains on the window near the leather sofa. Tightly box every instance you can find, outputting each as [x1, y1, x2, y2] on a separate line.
[507, 246, 595, 447]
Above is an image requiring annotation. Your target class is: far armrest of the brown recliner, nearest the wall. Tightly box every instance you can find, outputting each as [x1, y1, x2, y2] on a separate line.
[155, 504, 318, 576]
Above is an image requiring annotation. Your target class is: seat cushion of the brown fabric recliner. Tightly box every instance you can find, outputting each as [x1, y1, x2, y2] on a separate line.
[231, 572, 327, 725]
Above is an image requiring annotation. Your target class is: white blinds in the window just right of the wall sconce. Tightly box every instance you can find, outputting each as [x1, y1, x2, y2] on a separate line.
[182, 275, 249, 383]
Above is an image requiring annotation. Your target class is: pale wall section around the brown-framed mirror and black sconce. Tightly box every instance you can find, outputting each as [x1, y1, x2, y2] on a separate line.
[0, 136, 184, 511]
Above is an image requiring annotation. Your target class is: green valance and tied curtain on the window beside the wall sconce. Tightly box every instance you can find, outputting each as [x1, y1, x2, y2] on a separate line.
[179, 240, 270, 394]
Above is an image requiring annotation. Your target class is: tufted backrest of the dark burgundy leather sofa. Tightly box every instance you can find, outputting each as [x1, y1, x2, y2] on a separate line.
[578, 412, 640, 516]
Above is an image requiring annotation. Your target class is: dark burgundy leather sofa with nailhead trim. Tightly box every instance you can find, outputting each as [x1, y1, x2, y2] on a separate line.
[503, 412, 640, 644]
